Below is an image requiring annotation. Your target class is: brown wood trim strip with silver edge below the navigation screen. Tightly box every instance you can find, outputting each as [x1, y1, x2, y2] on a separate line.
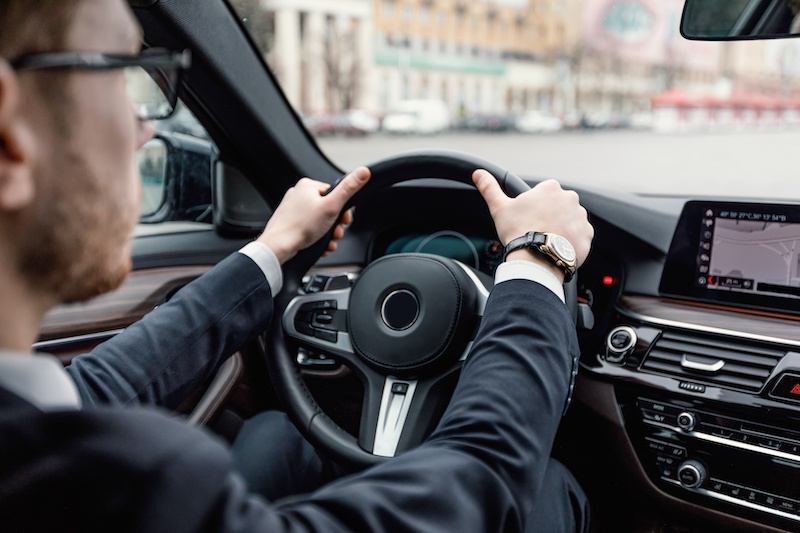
[619, 296, 800, 342]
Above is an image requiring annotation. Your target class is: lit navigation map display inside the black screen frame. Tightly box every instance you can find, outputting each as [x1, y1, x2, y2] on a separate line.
[695, 209, 800, 299]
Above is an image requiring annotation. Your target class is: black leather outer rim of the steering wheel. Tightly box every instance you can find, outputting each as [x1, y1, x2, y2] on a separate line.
[265, 150, 577, 469]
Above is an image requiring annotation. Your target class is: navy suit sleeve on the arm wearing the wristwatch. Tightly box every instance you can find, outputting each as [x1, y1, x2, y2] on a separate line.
[206, 280, 578, 533]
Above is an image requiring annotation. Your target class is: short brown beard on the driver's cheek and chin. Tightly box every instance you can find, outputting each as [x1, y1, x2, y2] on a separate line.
[19, 141, 140, 303]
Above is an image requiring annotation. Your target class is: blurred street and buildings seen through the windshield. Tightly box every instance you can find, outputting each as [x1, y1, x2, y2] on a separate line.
[230, 0, 800, 200]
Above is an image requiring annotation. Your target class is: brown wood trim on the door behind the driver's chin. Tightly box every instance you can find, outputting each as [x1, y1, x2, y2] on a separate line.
[39, 266, 211, 342]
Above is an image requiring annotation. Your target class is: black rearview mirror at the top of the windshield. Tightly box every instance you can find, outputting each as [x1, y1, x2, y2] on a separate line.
[681, 0, 800, 41]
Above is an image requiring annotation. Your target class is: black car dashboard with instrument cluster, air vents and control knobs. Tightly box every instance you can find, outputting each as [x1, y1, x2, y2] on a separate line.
[304, 181, 800, 531]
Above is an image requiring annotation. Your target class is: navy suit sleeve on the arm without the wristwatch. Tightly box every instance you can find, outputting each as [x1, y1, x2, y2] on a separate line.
[67, 253, 272, 409]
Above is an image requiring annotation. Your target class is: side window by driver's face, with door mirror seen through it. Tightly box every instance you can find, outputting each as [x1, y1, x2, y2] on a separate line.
[138, 102, 217, 224]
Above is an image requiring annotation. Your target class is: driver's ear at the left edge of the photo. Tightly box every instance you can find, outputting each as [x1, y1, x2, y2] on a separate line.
[0, 57, 35, 211]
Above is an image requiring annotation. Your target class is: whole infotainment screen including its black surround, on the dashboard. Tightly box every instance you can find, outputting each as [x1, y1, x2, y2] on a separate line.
[660, 201, 800, 314]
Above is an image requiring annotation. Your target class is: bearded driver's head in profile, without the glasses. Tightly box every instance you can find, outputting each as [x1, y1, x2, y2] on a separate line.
[0, 0, 152, 304]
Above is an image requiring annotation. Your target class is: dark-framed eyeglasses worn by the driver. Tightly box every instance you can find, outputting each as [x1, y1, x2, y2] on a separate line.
[11, 48, 192, 120]
